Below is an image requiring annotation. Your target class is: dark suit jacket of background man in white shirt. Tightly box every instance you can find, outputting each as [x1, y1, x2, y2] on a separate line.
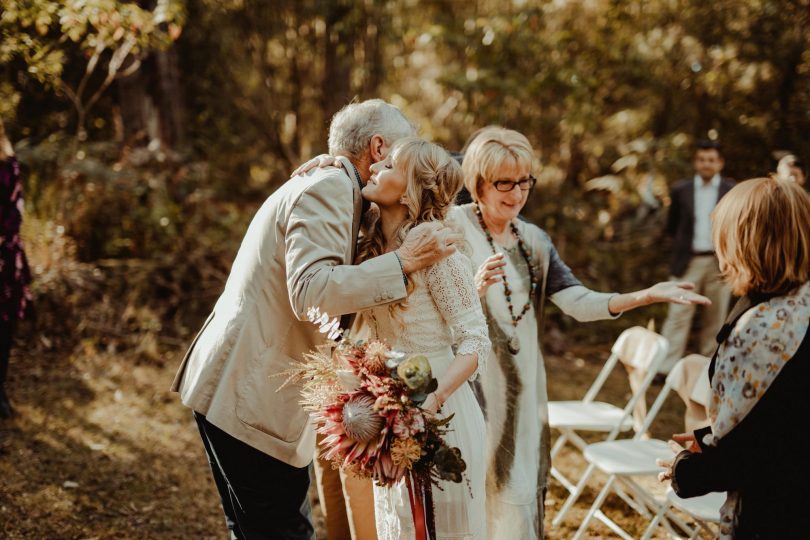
[667, 177, 735, 277]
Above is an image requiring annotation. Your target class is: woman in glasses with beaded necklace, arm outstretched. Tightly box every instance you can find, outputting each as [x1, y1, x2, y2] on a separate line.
[453, 126, 708, 539]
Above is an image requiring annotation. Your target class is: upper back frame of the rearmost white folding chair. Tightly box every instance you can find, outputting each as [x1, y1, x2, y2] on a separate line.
[583, 326, 668, 438]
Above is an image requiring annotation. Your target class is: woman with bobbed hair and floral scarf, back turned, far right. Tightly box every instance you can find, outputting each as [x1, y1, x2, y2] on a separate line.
[660, 178, 810, 540]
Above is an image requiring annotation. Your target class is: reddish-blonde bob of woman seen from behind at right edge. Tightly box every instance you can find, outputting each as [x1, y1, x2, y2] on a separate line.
[712, 178, 810, 296]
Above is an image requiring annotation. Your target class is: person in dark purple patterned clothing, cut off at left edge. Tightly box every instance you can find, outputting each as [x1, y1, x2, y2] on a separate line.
[0, 121, 31, 418]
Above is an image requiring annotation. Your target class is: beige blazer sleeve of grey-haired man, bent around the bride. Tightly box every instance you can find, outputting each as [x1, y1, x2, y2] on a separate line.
[284, 173, 407, 320]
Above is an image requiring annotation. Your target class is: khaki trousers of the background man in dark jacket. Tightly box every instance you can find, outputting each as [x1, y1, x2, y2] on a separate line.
[659, 255, 731, 373]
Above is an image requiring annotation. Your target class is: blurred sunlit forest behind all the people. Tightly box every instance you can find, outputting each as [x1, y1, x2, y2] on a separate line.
[0, 0, 810, 536]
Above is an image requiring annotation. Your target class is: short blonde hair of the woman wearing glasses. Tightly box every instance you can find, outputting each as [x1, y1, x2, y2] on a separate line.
[461, 126, 534, 202]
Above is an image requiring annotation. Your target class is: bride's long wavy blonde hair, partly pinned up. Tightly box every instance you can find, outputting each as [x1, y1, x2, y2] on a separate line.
[357, 137, 464, 262]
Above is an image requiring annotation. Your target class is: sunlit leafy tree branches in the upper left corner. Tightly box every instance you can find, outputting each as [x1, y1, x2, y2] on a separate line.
[0, 0, 184, 139]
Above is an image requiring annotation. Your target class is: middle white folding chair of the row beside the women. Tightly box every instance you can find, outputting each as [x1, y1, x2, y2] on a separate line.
[574, 361, 704, 540]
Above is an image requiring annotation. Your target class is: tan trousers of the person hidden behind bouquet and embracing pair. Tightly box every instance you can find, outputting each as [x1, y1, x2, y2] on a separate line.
[314, 435, 377, 540]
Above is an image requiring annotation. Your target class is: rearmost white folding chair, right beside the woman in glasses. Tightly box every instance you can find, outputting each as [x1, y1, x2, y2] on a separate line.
[548, 326, 667, 534]
